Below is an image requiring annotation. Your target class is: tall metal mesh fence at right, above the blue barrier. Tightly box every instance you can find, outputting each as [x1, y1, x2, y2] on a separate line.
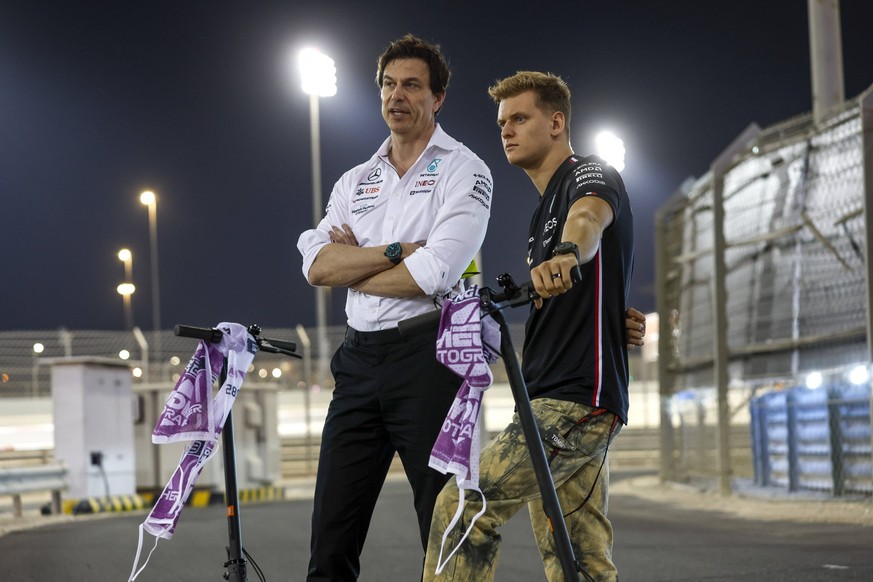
[656, 86, 873, 492]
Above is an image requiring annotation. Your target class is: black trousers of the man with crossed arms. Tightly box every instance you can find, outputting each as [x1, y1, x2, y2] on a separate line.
[306, 329, 462, 582]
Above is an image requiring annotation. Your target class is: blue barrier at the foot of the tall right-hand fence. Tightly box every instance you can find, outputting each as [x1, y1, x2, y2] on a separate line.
[750, 384, 873, 496]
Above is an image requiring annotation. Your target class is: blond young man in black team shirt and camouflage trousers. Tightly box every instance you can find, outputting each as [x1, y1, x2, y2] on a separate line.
[425, 72, 634, 581]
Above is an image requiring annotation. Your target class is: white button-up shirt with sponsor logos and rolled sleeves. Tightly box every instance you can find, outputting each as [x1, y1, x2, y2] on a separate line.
[297, 125, 493, 331]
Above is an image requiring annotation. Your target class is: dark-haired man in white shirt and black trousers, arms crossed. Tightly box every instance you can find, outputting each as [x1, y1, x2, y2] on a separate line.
[297, 35, 492, 582]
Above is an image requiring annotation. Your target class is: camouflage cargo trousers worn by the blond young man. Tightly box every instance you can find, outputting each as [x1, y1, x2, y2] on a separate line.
[424, 398, 621, 582]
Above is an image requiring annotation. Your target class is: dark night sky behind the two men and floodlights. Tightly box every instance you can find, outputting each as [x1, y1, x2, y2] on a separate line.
[0, 0, 873, 330]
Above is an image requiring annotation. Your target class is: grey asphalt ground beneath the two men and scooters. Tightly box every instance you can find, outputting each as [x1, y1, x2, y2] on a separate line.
[0, 474, 873, 582]
